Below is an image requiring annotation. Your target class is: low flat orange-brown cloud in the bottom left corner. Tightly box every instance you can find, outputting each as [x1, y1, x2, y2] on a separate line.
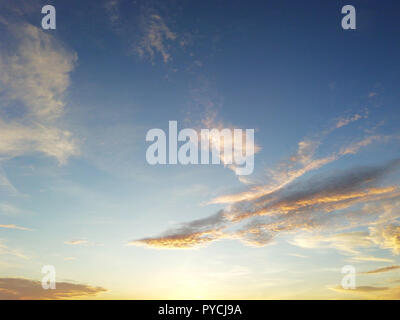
[0, 278, 107, 300]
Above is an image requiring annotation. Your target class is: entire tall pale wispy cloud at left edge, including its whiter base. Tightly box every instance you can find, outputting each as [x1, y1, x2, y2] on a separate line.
[0, 18, 79, 164]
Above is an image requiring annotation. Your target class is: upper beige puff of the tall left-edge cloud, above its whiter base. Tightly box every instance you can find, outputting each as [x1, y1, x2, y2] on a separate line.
[0, 23, 77, 119]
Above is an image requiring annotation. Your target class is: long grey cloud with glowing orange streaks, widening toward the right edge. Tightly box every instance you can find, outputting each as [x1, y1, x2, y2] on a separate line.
[130, 160, 400, 249]
